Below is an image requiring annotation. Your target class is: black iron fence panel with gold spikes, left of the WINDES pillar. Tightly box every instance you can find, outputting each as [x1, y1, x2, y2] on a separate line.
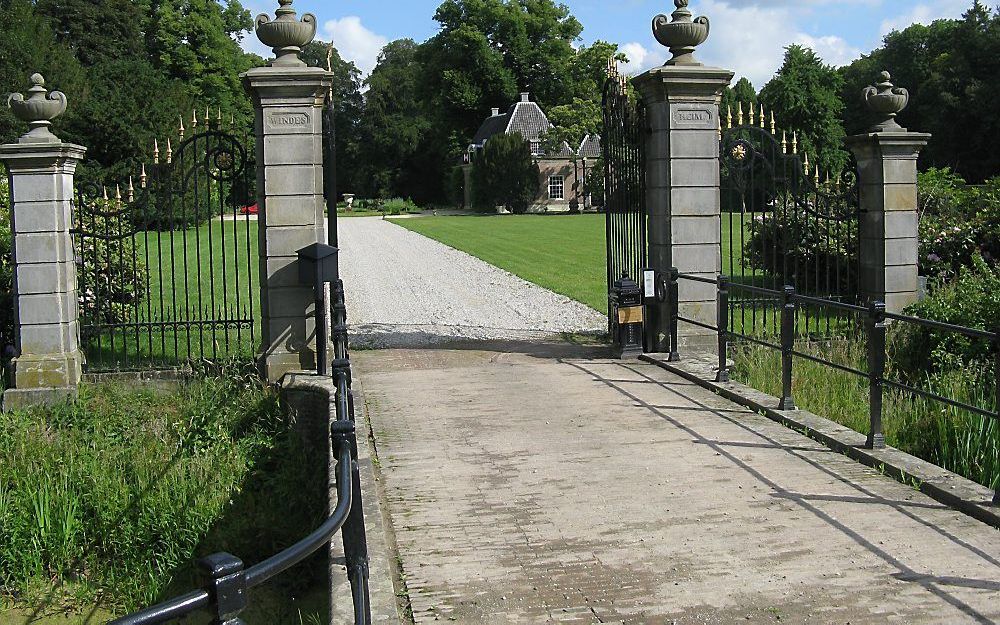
[73, 115, 259, 372]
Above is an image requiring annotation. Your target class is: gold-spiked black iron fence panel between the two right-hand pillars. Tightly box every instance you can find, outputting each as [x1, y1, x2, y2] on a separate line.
[720, 107, 860, 337]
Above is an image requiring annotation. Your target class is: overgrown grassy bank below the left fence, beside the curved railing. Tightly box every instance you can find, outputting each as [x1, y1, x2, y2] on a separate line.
[0, 365, 326, 622]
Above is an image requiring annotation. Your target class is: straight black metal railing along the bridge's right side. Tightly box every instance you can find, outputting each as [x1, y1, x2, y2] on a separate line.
[668, 269, 1000, 504]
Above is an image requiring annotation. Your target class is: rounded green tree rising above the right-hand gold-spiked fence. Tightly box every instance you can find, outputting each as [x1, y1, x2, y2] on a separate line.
[759, 45, 848, 175]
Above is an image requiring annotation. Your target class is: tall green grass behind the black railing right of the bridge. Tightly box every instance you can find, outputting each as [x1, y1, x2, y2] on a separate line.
[732, 340, 1000, 488]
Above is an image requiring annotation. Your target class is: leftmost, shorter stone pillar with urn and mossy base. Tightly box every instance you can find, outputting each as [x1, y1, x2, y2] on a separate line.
[0, 74, 86, 409]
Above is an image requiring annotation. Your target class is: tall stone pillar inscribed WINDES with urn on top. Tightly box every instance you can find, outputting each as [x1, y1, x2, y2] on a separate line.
[242, 0, 333, 382]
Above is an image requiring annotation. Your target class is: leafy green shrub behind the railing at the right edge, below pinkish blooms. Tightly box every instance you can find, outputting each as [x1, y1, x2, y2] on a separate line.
[892, 256, 1000, 376]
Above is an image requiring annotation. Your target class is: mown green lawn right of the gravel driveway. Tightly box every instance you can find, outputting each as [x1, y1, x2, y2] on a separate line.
[395, 214, 740, 313]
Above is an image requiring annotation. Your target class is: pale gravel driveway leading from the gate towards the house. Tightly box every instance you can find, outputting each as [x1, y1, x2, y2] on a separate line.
[339, 217, 607, 347]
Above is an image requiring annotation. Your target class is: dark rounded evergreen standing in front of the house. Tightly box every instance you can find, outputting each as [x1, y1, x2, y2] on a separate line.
[472, 132, 541, 214]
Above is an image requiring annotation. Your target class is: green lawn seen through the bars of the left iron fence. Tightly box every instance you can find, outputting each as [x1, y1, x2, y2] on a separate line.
[85, 219, 260, 371]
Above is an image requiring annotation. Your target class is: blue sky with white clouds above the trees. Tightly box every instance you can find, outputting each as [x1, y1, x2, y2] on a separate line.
[243, 0, 976, 88]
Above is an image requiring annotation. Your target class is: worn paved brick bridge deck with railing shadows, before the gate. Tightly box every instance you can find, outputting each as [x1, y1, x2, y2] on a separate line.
[356, 343, 1000, 625]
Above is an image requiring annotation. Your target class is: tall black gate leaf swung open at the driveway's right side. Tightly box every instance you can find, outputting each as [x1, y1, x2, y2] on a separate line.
[601, 71, 648, 327]
